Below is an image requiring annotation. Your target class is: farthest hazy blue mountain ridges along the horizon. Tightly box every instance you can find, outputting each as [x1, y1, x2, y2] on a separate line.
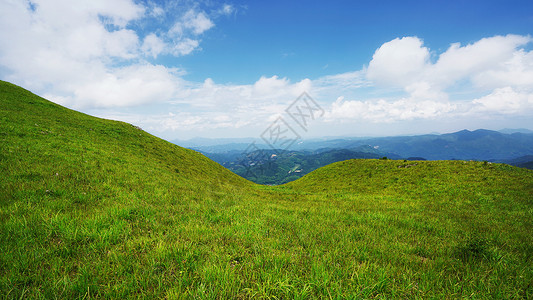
[179, 129, 533, 161]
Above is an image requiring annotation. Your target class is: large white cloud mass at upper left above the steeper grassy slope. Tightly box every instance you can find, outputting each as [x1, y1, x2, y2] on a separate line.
[0, 0, 221, 108]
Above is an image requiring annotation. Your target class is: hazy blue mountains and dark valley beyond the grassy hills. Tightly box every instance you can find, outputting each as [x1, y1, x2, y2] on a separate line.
[190, 129, 533, 184]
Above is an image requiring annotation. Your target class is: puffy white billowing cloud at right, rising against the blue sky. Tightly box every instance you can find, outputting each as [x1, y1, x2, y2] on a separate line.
[366, 35, 533, 90]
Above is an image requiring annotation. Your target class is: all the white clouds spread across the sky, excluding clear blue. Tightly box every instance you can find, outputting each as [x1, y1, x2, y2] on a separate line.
[0, 0, 533, 137]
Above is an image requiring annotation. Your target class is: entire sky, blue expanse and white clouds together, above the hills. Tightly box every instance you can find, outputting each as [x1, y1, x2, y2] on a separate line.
[0, 0, 533, 140]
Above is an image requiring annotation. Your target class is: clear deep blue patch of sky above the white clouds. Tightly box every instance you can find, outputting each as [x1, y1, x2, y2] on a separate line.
[177, 1, 533, 84]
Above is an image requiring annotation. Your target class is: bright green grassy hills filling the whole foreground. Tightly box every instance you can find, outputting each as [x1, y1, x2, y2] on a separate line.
[0, 82, 533, 299]
